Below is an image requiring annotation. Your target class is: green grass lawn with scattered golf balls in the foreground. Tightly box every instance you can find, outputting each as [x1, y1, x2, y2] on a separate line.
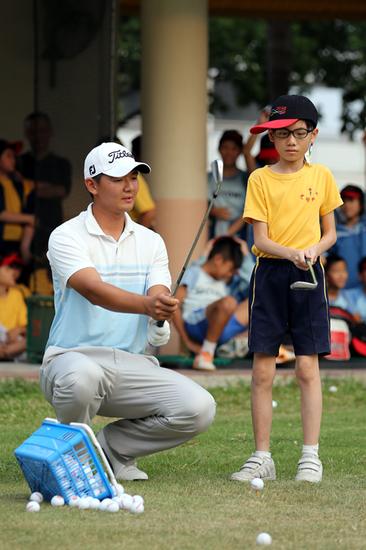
[0, 378, 366, 550]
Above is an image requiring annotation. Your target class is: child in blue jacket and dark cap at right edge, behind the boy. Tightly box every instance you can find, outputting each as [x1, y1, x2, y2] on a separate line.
[329, 184, 366, 289]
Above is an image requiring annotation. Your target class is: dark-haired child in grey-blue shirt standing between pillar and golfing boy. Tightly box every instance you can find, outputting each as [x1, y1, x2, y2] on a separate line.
[208, 130, 248, 242]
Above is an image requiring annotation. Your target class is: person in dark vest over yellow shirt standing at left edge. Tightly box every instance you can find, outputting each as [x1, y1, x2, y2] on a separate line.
[0, 139, 34, 262]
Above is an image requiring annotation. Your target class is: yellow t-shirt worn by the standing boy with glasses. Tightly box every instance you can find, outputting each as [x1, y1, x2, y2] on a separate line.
[243, 164, 342, 258]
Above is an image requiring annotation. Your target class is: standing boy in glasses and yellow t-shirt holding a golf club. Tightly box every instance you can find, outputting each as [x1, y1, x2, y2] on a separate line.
[231, 95, 342, 483]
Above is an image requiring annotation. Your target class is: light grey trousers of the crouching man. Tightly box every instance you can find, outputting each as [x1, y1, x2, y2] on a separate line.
[40, 347, 215, 462]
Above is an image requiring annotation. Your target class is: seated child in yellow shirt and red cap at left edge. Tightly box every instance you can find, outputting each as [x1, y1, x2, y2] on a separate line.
[0, 254, 27, 360]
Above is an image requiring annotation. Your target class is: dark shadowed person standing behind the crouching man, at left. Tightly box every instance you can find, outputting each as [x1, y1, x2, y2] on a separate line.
[19, 112, 71, 265]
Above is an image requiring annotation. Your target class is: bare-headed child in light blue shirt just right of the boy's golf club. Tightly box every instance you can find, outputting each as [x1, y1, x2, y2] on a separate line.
[324, 254, 352, 313]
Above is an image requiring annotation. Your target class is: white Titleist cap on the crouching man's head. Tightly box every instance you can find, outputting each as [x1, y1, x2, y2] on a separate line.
[84, 143, 151, 179]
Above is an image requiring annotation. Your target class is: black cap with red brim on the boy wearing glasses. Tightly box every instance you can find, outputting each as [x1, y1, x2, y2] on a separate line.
[250, 95, 318, 134]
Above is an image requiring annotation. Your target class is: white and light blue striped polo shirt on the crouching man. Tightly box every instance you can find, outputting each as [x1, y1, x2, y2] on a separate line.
[46, 205, 171, 355]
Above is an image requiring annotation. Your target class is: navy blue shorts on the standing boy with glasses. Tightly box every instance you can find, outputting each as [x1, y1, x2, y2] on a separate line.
[248, 258, 330, 356]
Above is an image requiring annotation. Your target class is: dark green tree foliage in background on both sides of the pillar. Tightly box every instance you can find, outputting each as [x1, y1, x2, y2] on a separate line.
[118, 17, 366, 135]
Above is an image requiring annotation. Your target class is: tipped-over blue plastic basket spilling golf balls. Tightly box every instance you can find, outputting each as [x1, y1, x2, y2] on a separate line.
[14, 418, 117, 502]
